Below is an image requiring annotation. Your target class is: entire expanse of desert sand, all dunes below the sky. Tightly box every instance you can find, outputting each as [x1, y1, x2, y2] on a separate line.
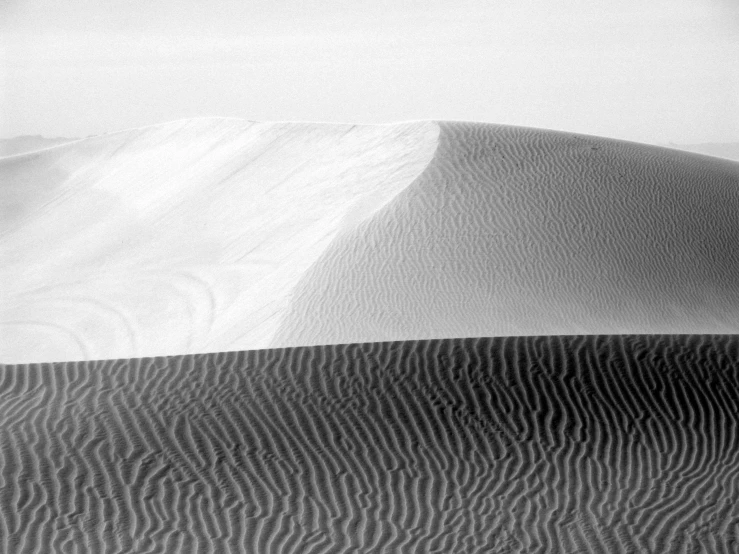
[0, 118, 739, 554]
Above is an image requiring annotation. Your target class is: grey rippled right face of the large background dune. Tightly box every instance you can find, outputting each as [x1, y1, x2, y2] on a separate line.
[273, 123, 739, 346]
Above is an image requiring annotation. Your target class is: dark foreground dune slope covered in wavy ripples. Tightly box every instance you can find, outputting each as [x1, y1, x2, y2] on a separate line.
[0, 336, 739, 553]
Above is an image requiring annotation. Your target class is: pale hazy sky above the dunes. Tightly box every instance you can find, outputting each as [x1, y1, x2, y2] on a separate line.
[0, 0, 739, 143]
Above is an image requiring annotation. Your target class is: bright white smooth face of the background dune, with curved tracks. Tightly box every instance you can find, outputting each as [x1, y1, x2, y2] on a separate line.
[0, 119, 439, 362]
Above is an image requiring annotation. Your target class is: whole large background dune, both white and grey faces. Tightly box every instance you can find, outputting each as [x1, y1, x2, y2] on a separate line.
[0, 119, 739, 363]
